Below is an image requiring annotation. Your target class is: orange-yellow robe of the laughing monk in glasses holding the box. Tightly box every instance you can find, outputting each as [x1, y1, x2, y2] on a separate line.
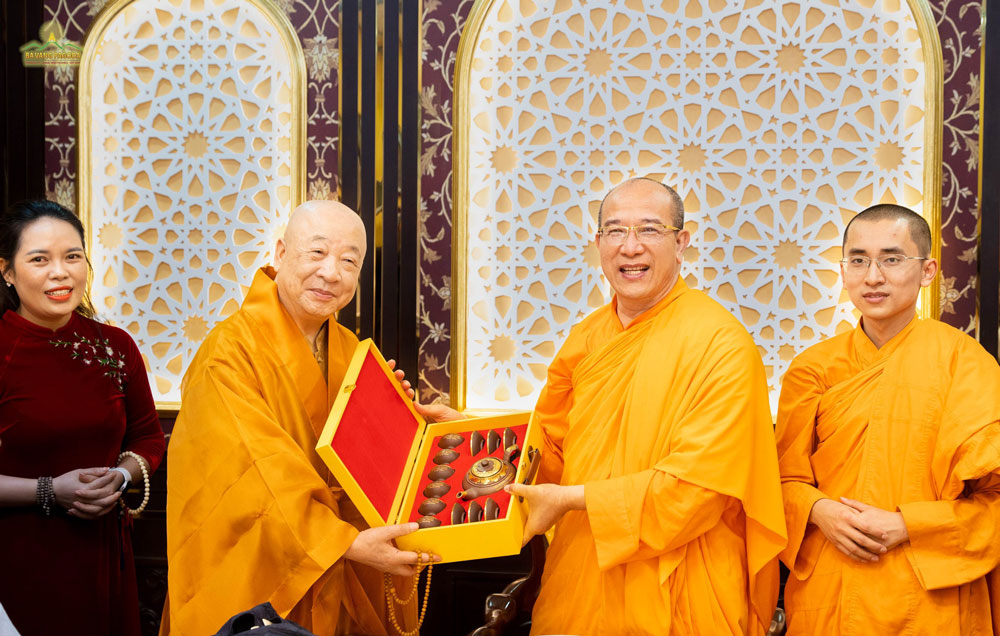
[532, 278, 785, 636]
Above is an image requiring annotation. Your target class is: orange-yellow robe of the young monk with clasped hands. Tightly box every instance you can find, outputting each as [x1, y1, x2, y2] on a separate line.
[777, 319, 1000, 636]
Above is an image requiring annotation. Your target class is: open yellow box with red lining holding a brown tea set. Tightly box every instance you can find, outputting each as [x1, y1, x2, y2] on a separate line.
[316, 339, 542, 563]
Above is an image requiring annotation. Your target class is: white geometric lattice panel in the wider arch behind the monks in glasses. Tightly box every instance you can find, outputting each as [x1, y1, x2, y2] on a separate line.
[453, 0, 940, 408]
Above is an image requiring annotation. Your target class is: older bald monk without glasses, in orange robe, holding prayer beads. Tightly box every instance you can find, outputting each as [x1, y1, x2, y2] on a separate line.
[161, 201, 431, 636]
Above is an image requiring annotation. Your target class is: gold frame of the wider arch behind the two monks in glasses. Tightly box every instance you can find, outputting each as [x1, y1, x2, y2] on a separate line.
[451, 0, 944, 410]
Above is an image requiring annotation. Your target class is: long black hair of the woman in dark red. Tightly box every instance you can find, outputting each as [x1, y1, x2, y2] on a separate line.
[0, 199, 94, 318]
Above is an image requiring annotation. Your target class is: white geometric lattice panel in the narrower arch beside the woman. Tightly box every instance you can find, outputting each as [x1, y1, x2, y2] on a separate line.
[81, 0, 304, 403]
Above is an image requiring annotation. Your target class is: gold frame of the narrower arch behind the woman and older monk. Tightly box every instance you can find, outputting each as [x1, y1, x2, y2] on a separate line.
[77, 0, 307, 413]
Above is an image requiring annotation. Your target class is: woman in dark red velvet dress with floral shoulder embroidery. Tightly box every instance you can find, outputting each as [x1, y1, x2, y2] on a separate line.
[0, 201, 165, 636]
